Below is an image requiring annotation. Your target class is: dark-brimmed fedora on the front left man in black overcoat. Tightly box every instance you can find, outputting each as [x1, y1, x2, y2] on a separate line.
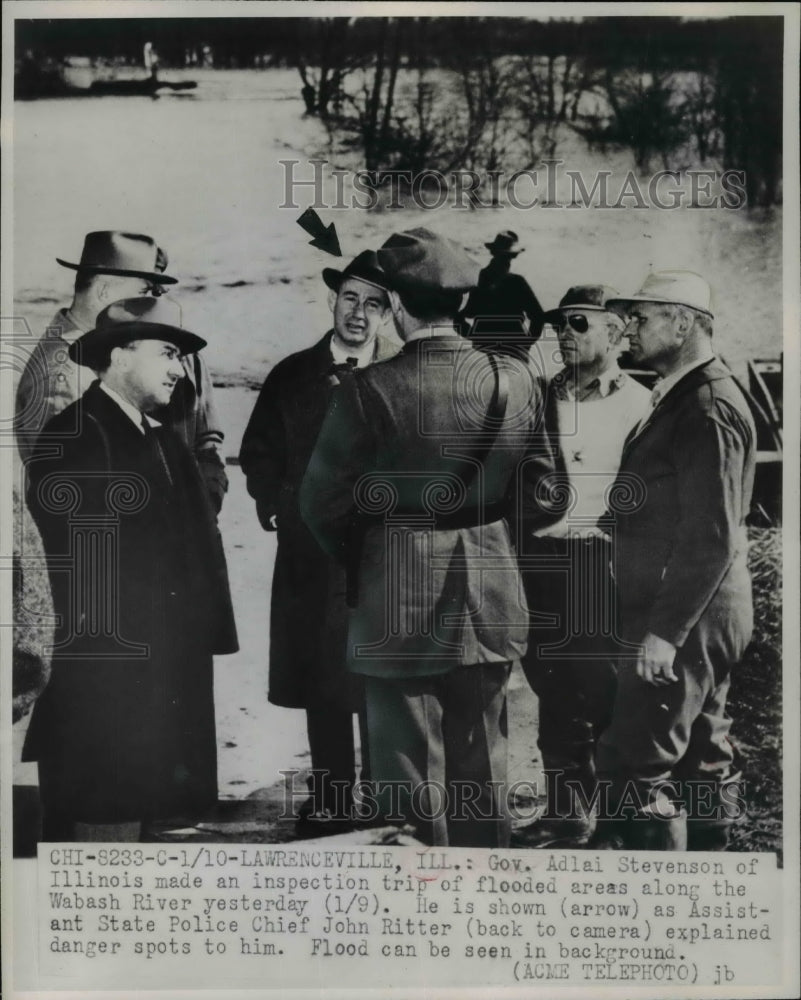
[69, 295, 206, 370]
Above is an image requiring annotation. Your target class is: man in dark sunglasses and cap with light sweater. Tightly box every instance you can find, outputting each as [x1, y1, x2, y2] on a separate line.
[513, 285, 648, 847]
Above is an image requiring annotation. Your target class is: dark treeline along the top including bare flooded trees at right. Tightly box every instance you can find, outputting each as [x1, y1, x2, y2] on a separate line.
[16, 16, 783, 205]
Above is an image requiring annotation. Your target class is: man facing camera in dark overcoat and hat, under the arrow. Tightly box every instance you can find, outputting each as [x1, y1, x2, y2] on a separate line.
[240, 250, 397, 832]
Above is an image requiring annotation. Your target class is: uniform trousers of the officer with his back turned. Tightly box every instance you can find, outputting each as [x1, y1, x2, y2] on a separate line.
[366, 663, 511, 847]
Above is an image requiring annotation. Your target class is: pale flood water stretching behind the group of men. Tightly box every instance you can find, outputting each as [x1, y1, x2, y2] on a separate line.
[13, 69, 781, 394]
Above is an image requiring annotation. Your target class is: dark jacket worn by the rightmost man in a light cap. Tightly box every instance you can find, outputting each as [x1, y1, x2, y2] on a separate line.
[609, 359, 756, 664]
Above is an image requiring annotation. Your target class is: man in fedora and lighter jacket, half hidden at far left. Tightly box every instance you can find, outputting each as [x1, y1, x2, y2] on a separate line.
[15, 230, 228, 512]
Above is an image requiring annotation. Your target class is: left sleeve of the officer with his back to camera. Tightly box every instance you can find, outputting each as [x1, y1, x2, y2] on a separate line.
[300, 375, 376, 562]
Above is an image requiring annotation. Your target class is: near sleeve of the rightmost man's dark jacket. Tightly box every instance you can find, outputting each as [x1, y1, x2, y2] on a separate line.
[648, 400, 753, 646]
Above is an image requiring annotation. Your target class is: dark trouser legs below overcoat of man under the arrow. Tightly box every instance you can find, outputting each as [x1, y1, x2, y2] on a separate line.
[306, 704, 370, 817]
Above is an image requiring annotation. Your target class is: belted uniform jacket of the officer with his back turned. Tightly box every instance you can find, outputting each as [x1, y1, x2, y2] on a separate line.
[301, 334, 547, 678]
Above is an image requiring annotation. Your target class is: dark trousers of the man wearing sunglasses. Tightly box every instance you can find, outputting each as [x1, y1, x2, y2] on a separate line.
[522, 537, 625, 781]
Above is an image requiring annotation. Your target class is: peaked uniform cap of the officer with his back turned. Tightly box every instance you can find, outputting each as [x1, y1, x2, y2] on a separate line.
[378, 227, 479, 293]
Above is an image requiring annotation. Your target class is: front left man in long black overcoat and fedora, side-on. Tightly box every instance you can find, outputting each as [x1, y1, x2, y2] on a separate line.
[23, 296, 237, 840]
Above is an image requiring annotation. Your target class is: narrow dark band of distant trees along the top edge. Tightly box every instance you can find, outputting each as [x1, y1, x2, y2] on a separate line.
[15, 17, 782, 69]
